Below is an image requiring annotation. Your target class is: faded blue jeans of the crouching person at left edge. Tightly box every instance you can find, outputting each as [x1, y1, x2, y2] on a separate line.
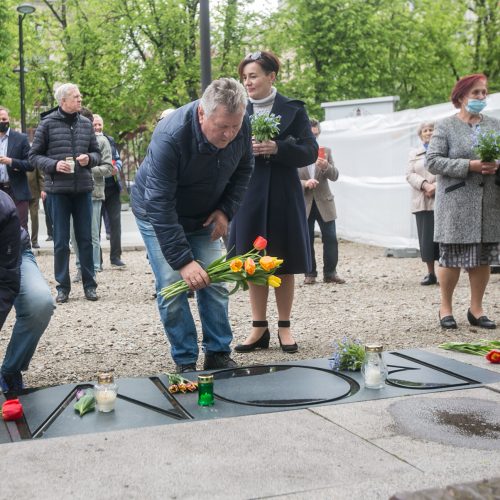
[1, 250, 54, 375]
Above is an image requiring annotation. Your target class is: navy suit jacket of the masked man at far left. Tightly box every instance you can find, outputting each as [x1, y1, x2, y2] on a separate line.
[6, 129, 34, 201]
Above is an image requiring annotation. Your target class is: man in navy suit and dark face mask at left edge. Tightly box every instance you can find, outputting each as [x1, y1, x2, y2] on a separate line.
[0, 106, 33, 231]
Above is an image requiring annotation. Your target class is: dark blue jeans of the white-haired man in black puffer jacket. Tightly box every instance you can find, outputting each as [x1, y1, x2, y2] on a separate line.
[47, 193, 97, 293]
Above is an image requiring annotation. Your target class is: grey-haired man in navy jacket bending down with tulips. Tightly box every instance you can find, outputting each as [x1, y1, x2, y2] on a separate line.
[132, 78, 254, 372]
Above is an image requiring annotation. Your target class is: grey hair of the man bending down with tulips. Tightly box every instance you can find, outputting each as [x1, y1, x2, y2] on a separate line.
[200, 78, 247, 116]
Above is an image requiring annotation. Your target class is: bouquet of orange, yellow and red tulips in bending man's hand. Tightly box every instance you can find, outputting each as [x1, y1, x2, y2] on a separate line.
[160, 236, 283, 299]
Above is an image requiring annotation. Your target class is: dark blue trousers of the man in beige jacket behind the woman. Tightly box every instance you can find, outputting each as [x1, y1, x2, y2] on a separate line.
[306, 201, 339, 278]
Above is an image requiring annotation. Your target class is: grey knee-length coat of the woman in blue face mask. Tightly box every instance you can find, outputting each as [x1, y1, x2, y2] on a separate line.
[426, 115, 500, 244]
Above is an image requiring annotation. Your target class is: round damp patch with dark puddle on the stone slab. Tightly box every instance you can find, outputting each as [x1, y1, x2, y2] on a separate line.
[389, 398, 500, 450]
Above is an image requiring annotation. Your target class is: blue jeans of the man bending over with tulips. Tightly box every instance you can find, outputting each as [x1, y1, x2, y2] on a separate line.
[136, 218, 233, 365]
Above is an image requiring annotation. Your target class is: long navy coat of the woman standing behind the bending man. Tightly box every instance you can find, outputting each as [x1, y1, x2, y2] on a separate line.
[229, 93, 318, 274]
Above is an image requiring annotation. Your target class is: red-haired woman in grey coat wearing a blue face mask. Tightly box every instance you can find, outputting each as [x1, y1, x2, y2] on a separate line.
[427, 74, 500, 328]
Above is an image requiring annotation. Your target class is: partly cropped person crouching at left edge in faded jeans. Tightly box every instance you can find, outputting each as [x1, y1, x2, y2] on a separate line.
[0, 191, 54, 392]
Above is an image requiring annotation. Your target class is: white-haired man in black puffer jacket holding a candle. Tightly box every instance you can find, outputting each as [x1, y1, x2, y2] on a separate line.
[29, 83, 101, 303]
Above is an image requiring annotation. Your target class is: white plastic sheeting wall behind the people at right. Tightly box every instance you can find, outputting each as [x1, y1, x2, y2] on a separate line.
[319, 93, 500, 248]
